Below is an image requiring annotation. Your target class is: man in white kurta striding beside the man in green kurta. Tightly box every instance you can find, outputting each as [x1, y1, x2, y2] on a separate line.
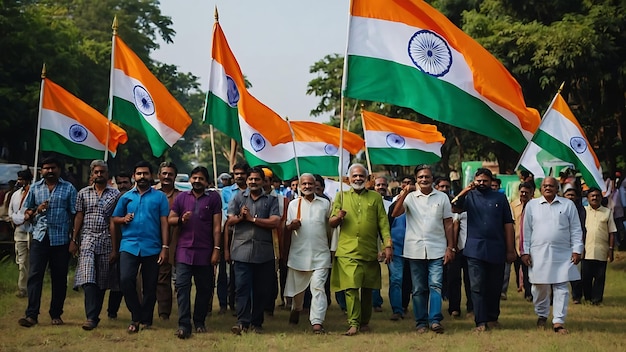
[285, 173, 331, 333]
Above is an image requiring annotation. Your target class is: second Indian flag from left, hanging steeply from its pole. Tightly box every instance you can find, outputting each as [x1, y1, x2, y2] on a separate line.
[111, 36, 191, 157]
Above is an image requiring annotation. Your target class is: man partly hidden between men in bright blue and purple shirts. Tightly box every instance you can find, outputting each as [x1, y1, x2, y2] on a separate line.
[154, 161, 180, 320]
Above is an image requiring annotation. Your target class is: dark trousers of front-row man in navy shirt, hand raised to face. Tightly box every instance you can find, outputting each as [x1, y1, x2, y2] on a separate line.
[467, 257, 504, 326]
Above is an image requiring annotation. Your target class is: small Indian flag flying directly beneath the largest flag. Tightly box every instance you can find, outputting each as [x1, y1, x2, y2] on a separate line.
[363, 111, 446, 166]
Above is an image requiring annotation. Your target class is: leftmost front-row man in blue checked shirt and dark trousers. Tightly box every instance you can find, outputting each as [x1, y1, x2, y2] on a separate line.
[18, 158, 76, 328]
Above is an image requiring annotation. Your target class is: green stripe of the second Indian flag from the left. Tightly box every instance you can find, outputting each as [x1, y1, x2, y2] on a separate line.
[113, 97, 170, 157]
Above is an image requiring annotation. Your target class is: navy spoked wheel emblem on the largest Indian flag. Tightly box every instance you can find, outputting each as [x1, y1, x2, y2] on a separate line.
[408, 30, 452, 77]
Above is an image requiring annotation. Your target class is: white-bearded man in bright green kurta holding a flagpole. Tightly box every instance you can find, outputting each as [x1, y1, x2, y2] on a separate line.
[330, 164, 393, 336]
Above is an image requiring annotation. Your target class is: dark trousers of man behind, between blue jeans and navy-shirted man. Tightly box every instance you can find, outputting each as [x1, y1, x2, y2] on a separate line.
[447, 251, 474, 314]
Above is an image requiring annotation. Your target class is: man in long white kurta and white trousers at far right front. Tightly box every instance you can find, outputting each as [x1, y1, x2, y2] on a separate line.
[521, 177, 583, 334]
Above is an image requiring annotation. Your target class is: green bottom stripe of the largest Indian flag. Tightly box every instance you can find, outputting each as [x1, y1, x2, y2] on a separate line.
[345, 55, 528, 152]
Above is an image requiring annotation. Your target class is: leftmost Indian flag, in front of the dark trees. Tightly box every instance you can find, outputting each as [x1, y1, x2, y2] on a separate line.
[39, 78, 128, 159]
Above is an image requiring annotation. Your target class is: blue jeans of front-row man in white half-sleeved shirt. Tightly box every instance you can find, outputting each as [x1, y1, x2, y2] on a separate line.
[409, 258, 443, 327]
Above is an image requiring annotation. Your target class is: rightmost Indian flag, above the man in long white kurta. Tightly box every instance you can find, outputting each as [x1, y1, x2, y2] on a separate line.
[519, 94, 606, 192]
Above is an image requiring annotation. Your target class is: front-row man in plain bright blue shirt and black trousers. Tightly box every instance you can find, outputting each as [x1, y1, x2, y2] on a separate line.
[113, 161, 169, 333]
